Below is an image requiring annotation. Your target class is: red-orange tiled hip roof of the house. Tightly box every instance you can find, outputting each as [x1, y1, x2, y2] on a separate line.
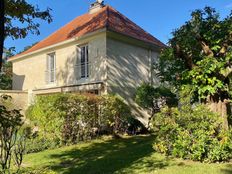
[13, 6, 166, 58]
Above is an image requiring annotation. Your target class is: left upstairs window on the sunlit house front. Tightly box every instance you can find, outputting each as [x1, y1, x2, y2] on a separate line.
[46, 53, 56, 84]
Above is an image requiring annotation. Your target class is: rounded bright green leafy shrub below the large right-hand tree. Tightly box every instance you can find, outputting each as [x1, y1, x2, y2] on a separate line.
[153, 105, 232, 162]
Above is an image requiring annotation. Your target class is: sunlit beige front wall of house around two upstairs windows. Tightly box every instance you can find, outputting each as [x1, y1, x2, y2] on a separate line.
[12, 33, 106, 91]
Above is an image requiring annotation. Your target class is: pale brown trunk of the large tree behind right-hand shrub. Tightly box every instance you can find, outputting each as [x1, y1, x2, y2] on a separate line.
[209, 100, 229, 130]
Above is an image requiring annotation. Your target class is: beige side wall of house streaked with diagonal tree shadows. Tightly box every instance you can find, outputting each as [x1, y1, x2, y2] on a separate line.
[107, 34, 158, 124]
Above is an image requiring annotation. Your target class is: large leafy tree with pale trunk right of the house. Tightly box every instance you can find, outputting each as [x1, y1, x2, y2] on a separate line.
[155, 7, 232, 129]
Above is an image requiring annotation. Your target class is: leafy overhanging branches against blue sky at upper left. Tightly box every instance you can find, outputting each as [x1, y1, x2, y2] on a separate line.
[5, 0, 52, 39]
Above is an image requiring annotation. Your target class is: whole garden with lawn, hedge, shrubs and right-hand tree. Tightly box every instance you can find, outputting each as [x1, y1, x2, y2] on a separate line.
[0, 4, 232, 174]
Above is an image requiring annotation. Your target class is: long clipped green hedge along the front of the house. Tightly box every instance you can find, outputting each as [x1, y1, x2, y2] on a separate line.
[26, 94, 131, 151]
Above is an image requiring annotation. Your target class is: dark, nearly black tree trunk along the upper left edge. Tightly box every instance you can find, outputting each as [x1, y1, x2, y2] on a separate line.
[0, 0, 5, 71]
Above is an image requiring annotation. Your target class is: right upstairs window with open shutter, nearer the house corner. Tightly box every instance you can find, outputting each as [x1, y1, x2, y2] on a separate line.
[80, 45, 89, 78]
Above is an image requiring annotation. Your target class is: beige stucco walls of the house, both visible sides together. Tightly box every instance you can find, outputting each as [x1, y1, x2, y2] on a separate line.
[9, 31, 159, 124]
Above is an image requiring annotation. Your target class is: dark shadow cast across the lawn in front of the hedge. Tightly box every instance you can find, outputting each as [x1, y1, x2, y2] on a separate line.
[45, 136, 168, 174]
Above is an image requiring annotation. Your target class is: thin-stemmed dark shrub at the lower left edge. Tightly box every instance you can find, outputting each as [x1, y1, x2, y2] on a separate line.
[0, 95, 25, 173]
